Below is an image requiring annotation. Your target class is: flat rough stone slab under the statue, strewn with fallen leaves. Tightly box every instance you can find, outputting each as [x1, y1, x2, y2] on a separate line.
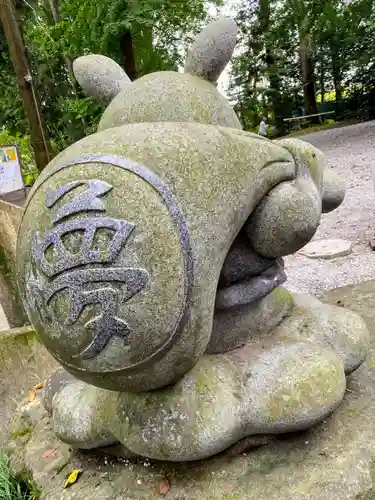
[8, 282, 375, 500]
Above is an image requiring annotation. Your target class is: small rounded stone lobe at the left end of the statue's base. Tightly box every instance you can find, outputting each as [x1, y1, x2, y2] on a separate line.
[51, 380, 118, 450]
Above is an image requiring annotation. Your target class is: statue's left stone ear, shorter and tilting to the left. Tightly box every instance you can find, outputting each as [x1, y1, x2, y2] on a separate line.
[73, 54, 131, 104]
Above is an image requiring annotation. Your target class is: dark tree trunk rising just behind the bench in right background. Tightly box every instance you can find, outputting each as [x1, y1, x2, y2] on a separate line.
[299, 33, 319, 123]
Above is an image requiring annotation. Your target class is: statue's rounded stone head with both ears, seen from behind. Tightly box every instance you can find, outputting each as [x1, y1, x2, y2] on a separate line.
[74, 18, 241, 130]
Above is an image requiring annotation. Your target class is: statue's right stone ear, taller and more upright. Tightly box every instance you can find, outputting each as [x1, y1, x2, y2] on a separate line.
[185, 17, 237, 83]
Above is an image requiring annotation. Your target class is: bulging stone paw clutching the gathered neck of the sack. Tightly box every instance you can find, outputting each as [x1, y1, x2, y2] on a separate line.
[245, 139, 339, 258]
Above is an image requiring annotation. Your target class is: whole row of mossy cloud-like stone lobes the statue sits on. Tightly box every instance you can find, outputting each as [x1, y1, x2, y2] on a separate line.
[41, 290, 368, 461]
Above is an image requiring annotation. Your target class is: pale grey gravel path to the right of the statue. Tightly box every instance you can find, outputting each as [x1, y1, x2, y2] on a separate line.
[285, 121, 375, 295]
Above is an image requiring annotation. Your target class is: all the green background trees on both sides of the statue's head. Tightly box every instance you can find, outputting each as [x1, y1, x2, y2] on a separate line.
[4, 0, 375, 146]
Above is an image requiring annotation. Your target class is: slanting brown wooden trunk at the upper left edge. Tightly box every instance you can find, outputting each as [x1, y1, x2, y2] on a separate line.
[0, 0, 53, 171]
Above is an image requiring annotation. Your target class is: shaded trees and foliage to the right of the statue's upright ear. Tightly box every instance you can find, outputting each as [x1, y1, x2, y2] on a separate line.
[230, 0, 375, 133]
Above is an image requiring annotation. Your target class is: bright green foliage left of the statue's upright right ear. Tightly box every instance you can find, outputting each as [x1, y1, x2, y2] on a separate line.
[0, 0, 221, 151]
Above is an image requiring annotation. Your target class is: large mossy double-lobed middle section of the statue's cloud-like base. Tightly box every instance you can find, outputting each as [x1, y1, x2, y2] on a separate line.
[111, 339, 346, 461]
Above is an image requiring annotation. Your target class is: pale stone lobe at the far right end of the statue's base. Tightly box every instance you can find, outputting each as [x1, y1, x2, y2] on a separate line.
[284, 294, 369, 375]
